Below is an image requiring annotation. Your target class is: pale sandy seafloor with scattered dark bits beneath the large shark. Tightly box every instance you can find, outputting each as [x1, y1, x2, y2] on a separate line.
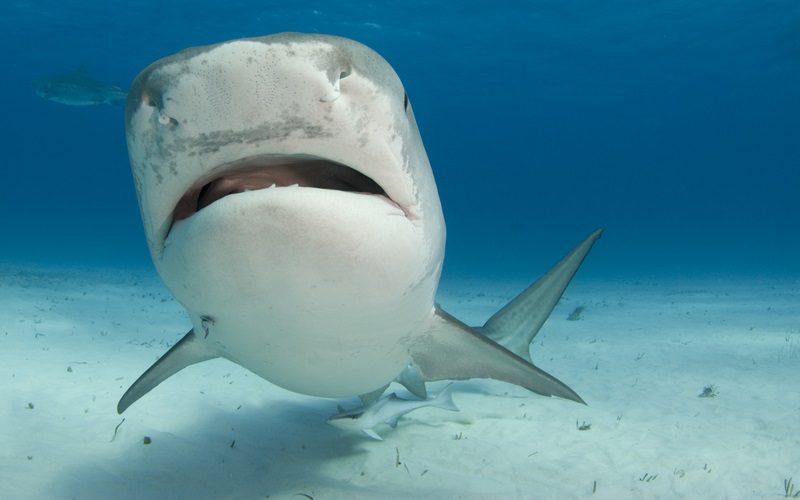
[0, 266, 800, 499]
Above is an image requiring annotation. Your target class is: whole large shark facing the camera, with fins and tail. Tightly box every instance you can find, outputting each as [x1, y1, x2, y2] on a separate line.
[117, 33, 600, 413]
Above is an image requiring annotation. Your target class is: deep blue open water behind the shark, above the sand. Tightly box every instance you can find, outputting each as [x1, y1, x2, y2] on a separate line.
[0, 0, 800, 278]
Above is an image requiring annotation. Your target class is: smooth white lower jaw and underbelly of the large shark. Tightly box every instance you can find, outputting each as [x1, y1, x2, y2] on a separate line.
[157, 187, 439, 397]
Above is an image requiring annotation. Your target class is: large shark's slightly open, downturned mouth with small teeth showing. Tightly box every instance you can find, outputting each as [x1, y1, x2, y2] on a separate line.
[172, 156, 390, 228]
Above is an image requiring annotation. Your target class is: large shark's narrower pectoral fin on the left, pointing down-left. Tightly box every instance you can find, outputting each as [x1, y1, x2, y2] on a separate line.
[117, 330, 218, 413]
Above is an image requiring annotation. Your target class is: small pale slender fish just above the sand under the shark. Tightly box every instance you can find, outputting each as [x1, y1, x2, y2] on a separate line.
[328, 384, 459, 441]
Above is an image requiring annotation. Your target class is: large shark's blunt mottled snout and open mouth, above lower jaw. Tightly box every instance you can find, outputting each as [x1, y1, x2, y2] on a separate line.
[126, 33, 441, 255]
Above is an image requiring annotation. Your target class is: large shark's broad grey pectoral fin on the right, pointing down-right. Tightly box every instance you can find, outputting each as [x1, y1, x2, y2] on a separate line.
[409, 306, 586, 404]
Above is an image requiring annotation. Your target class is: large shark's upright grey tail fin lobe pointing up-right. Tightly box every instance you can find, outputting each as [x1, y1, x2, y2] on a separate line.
[478, 229, 603, 361]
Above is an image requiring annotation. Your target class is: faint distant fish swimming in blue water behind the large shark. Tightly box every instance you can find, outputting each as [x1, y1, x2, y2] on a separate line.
[33, 66, 128, 106]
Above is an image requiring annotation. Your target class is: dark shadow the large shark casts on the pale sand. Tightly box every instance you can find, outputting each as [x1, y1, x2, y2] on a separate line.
[49, 399, 394, 499]
